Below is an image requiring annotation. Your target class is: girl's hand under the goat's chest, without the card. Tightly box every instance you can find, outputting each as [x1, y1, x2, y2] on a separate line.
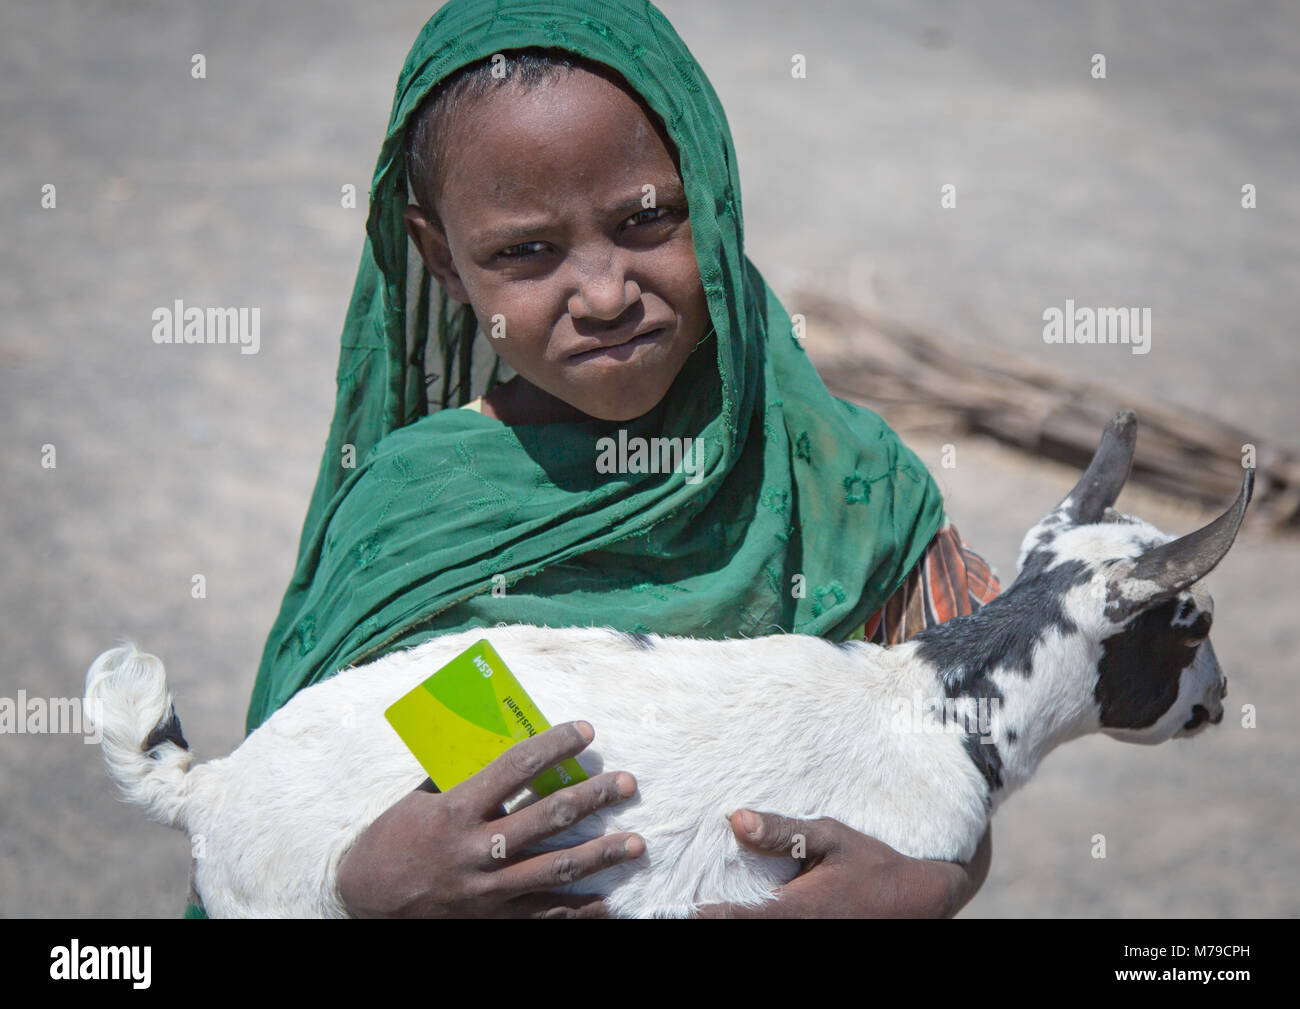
[699, 810, 993, 918]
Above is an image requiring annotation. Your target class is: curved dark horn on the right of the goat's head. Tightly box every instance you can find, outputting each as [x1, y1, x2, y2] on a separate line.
[1106, 469, 1255, 623]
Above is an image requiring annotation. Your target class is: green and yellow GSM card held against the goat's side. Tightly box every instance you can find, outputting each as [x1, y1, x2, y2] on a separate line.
[385, 638, 586, 796]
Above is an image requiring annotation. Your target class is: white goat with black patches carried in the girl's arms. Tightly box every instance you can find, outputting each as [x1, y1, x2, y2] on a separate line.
[86, 411, 1253, 917]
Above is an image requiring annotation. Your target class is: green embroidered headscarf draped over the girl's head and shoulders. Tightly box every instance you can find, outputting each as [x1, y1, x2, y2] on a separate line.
[247, 0, 943, 732]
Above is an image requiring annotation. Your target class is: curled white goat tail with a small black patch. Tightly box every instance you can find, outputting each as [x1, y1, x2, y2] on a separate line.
[85, 642, 192, 830]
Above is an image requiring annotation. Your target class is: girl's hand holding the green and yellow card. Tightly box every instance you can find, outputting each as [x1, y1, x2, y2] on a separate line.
[338, 722, 645, 918]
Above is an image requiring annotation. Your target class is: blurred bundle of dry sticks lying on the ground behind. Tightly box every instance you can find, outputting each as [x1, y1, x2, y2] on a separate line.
[790, 290, 1300, 532]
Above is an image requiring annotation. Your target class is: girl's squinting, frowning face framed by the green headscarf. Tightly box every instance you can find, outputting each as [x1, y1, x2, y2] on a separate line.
[407, 62, 709, 423]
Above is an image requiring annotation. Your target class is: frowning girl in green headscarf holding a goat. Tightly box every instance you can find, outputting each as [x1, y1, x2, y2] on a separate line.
[208, 0, 997, 915]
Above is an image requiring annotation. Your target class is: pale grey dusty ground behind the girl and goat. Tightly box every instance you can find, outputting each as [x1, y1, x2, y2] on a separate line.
[0, 0, 1300, 917]
